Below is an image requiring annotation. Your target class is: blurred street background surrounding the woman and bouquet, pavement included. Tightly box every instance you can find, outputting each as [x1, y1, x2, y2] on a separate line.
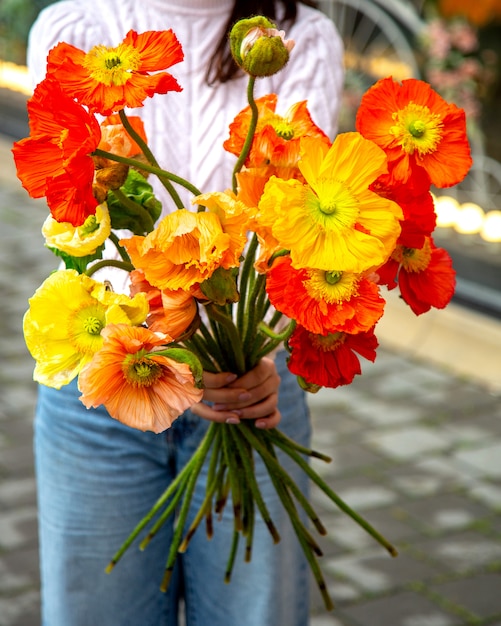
[0, 0, 501, 626]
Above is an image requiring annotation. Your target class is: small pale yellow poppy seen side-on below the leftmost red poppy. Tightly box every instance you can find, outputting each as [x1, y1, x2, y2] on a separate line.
[42, 203, 111, 257]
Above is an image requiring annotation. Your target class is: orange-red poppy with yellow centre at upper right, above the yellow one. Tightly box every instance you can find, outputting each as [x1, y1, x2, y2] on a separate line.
[356, 77, 472, 187]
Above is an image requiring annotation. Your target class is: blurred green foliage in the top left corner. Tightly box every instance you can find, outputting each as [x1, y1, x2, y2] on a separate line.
[0, 0, 55, 65]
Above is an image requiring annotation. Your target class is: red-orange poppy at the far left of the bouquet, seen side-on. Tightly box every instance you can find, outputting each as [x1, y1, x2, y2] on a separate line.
[12, 79, 101, 226]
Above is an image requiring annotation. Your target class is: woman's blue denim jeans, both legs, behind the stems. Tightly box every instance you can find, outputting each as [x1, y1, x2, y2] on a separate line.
[35, 355, 310, 626]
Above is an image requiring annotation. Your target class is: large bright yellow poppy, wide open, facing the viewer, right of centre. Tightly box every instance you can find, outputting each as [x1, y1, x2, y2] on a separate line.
[258, 133, 403, 273]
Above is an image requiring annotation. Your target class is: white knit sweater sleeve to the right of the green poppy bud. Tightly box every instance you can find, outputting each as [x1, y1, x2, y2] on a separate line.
[271, 5, 344, 139]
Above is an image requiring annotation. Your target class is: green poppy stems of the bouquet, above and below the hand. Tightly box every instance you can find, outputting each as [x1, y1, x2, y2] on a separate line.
[96, 77, 397, 610]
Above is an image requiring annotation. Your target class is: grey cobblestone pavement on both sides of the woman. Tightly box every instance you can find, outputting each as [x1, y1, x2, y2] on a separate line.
[0, 137, 501, 626]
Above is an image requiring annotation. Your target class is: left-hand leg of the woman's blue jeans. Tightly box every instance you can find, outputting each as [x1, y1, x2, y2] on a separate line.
[35, 384, 182, 626]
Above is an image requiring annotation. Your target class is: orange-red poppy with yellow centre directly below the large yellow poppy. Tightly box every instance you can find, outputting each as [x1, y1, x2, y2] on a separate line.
[266, 257, 385, 335]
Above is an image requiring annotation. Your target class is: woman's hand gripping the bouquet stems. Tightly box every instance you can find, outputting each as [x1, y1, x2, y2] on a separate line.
[191, 358, 281, 428]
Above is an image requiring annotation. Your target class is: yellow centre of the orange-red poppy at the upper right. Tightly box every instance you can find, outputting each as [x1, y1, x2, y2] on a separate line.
[390, 102, 443, 156]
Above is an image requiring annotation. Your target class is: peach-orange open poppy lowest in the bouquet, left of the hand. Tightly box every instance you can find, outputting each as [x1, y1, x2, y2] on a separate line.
[78, 324, 203, 433]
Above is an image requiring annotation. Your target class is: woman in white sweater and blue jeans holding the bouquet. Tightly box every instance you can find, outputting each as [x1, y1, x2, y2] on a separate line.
[29, 0, 342, 626]
